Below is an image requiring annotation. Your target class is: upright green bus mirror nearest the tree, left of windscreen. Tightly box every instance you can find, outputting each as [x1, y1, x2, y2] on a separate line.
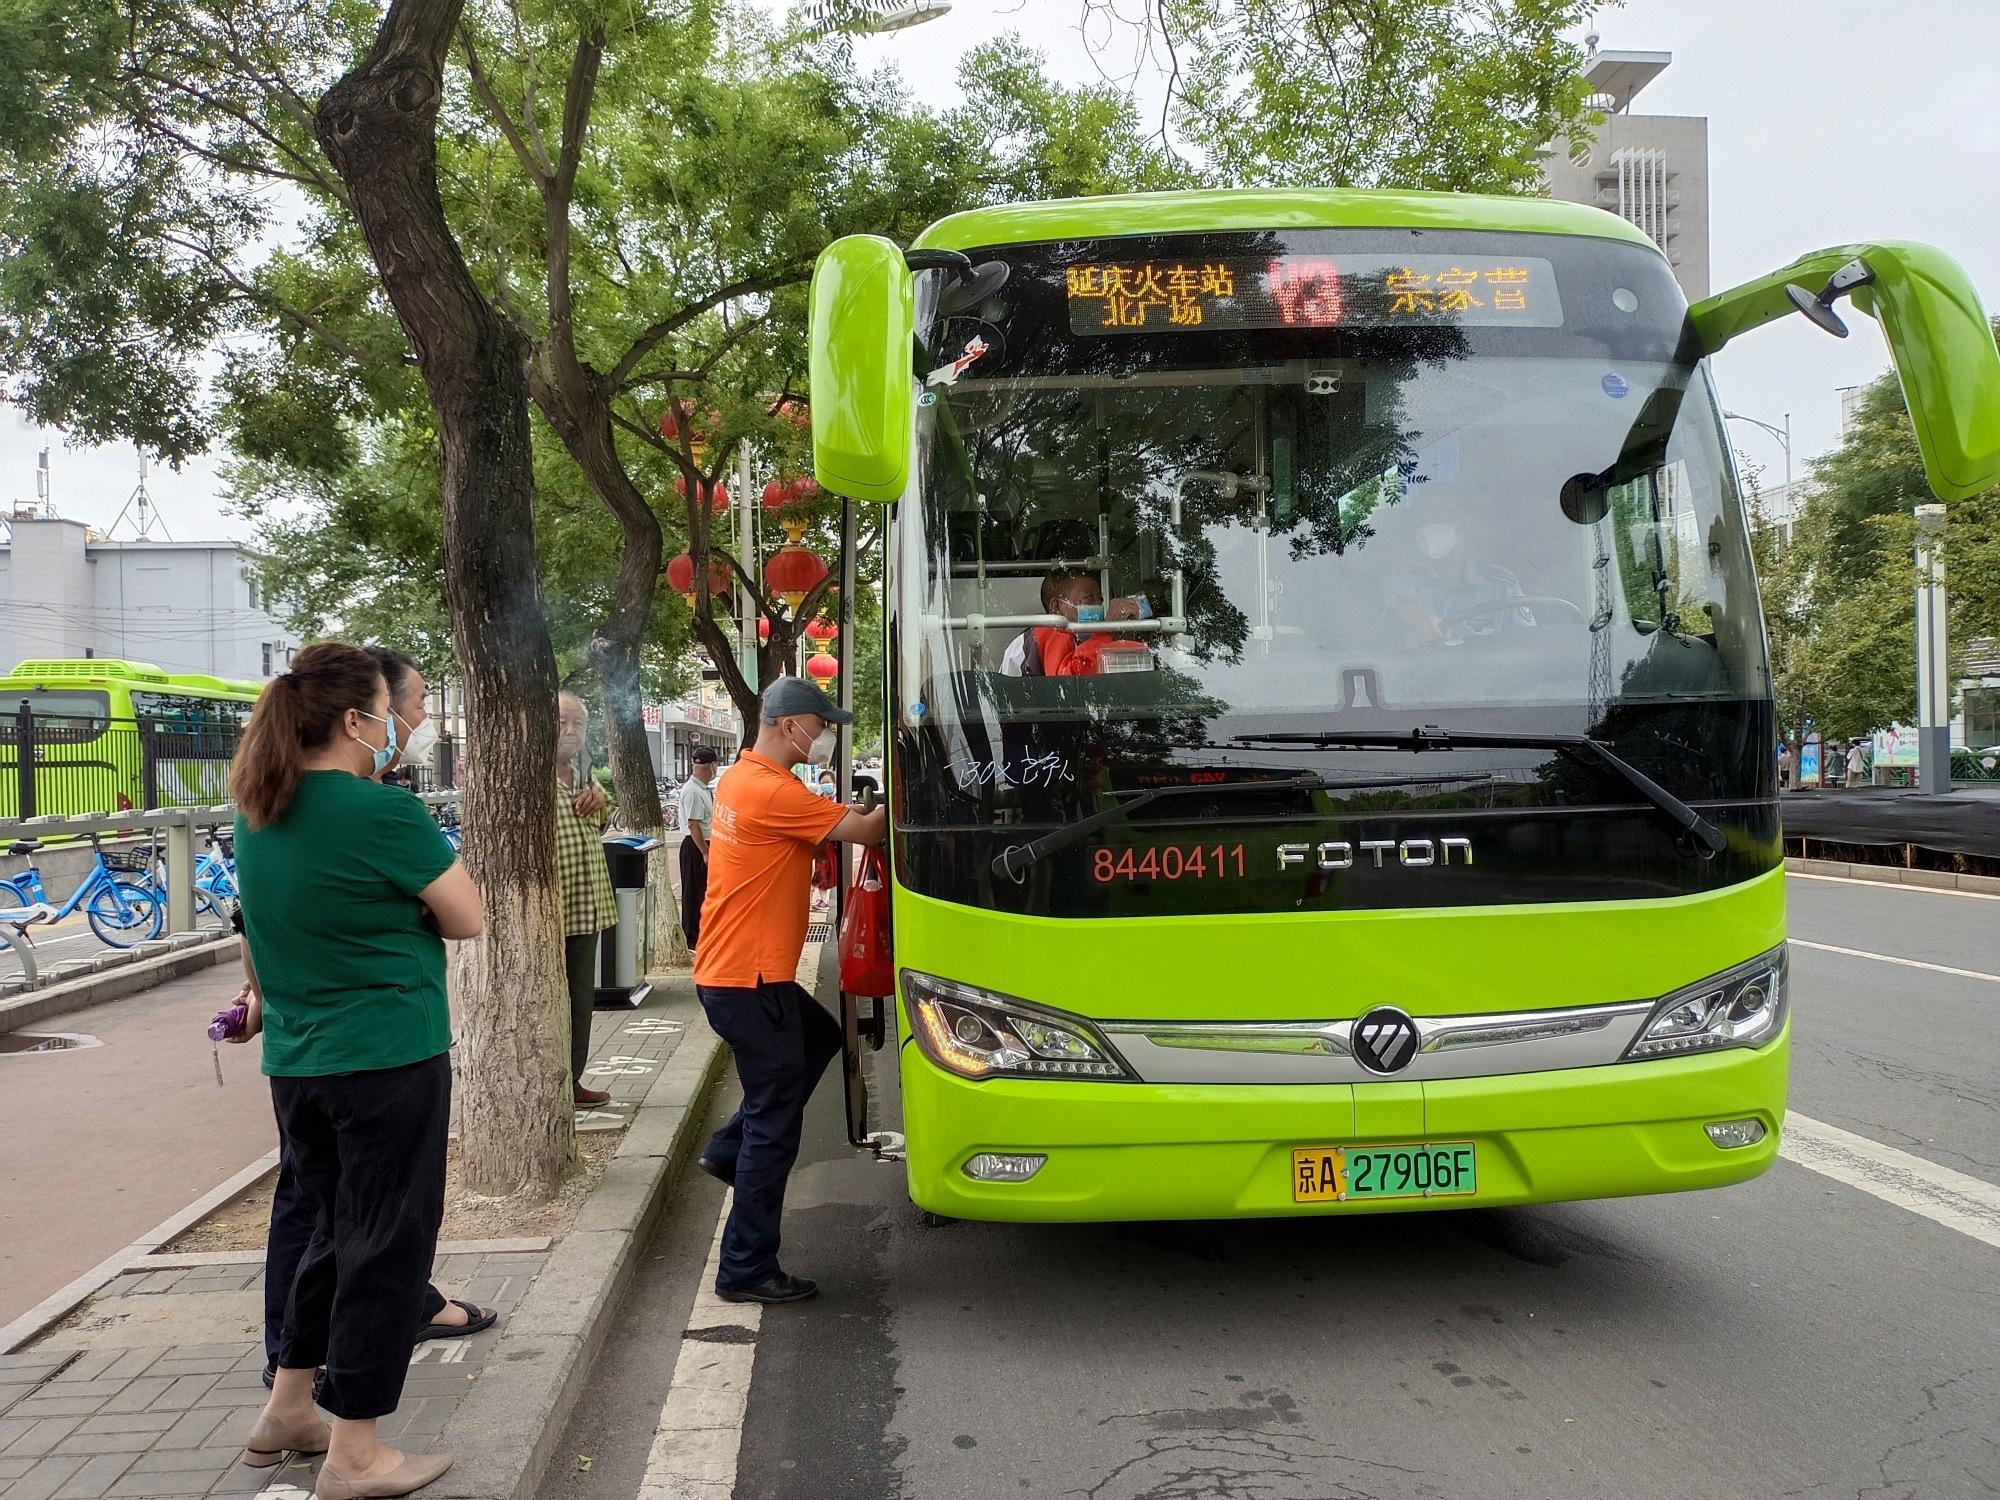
[810, 234, 916, 504]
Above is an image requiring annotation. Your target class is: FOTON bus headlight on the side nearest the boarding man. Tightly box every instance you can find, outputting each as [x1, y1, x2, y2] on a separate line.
[902, 968, 1132, 1080]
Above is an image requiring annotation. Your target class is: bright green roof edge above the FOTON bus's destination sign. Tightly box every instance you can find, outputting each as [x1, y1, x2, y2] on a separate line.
[914, 188, 1658, 250]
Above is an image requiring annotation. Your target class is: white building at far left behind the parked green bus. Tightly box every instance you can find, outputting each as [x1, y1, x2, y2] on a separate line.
[0, 508, 298, 680]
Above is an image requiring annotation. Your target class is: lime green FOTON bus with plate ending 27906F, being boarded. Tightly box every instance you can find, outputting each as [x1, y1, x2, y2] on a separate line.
[810, 190, 2000, 1220]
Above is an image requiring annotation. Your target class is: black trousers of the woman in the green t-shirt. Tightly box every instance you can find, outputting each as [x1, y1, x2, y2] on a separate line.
[266, 1052, 452, 1422]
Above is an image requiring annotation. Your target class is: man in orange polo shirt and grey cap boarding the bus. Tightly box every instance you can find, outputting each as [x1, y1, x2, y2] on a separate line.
[694, 678, 888, 1302]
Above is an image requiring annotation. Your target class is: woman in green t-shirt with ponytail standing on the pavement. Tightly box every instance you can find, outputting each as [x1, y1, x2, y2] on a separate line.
[230, 642, 484, 1500]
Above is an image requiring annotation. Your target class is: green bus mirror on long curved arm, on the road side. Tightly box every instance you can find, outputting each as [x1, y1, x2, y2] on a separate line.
[1688, 240, 2000, 500]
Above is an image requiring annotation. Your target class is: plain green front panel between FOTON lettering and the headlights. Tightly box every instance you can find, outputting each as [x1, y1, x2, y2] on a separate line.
[894, 870, 1784, 1020]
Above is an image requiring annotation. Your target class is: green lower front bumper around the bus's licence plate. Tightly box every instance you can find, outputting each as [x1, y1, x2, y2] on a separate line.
[902, 1024, 1792, 1222]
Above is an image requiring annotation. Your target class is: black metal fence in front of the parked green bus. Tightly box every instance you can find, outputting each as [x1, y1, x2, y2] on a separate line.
[0, 704, 242, 818]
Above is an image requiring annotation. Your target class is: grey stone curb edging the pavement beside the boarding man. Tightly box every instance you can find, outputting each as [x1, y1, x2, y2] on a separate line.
[426, 1000, 726, 1500]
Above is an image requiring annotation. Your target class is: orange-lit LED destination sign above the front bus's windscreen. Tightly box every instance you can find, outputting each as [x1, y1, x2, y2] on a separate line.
[1066, 254, 1562, 334]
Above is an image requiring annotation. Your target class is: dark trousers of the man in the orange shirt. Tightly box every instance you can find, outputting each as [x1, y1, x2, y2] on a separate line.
[696, 982, 840, 1290]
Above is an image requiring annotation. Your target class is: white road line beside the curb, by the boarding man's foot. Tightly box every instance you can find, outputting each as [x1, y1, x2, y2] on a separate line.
[638, 1192, 764, 1500]
